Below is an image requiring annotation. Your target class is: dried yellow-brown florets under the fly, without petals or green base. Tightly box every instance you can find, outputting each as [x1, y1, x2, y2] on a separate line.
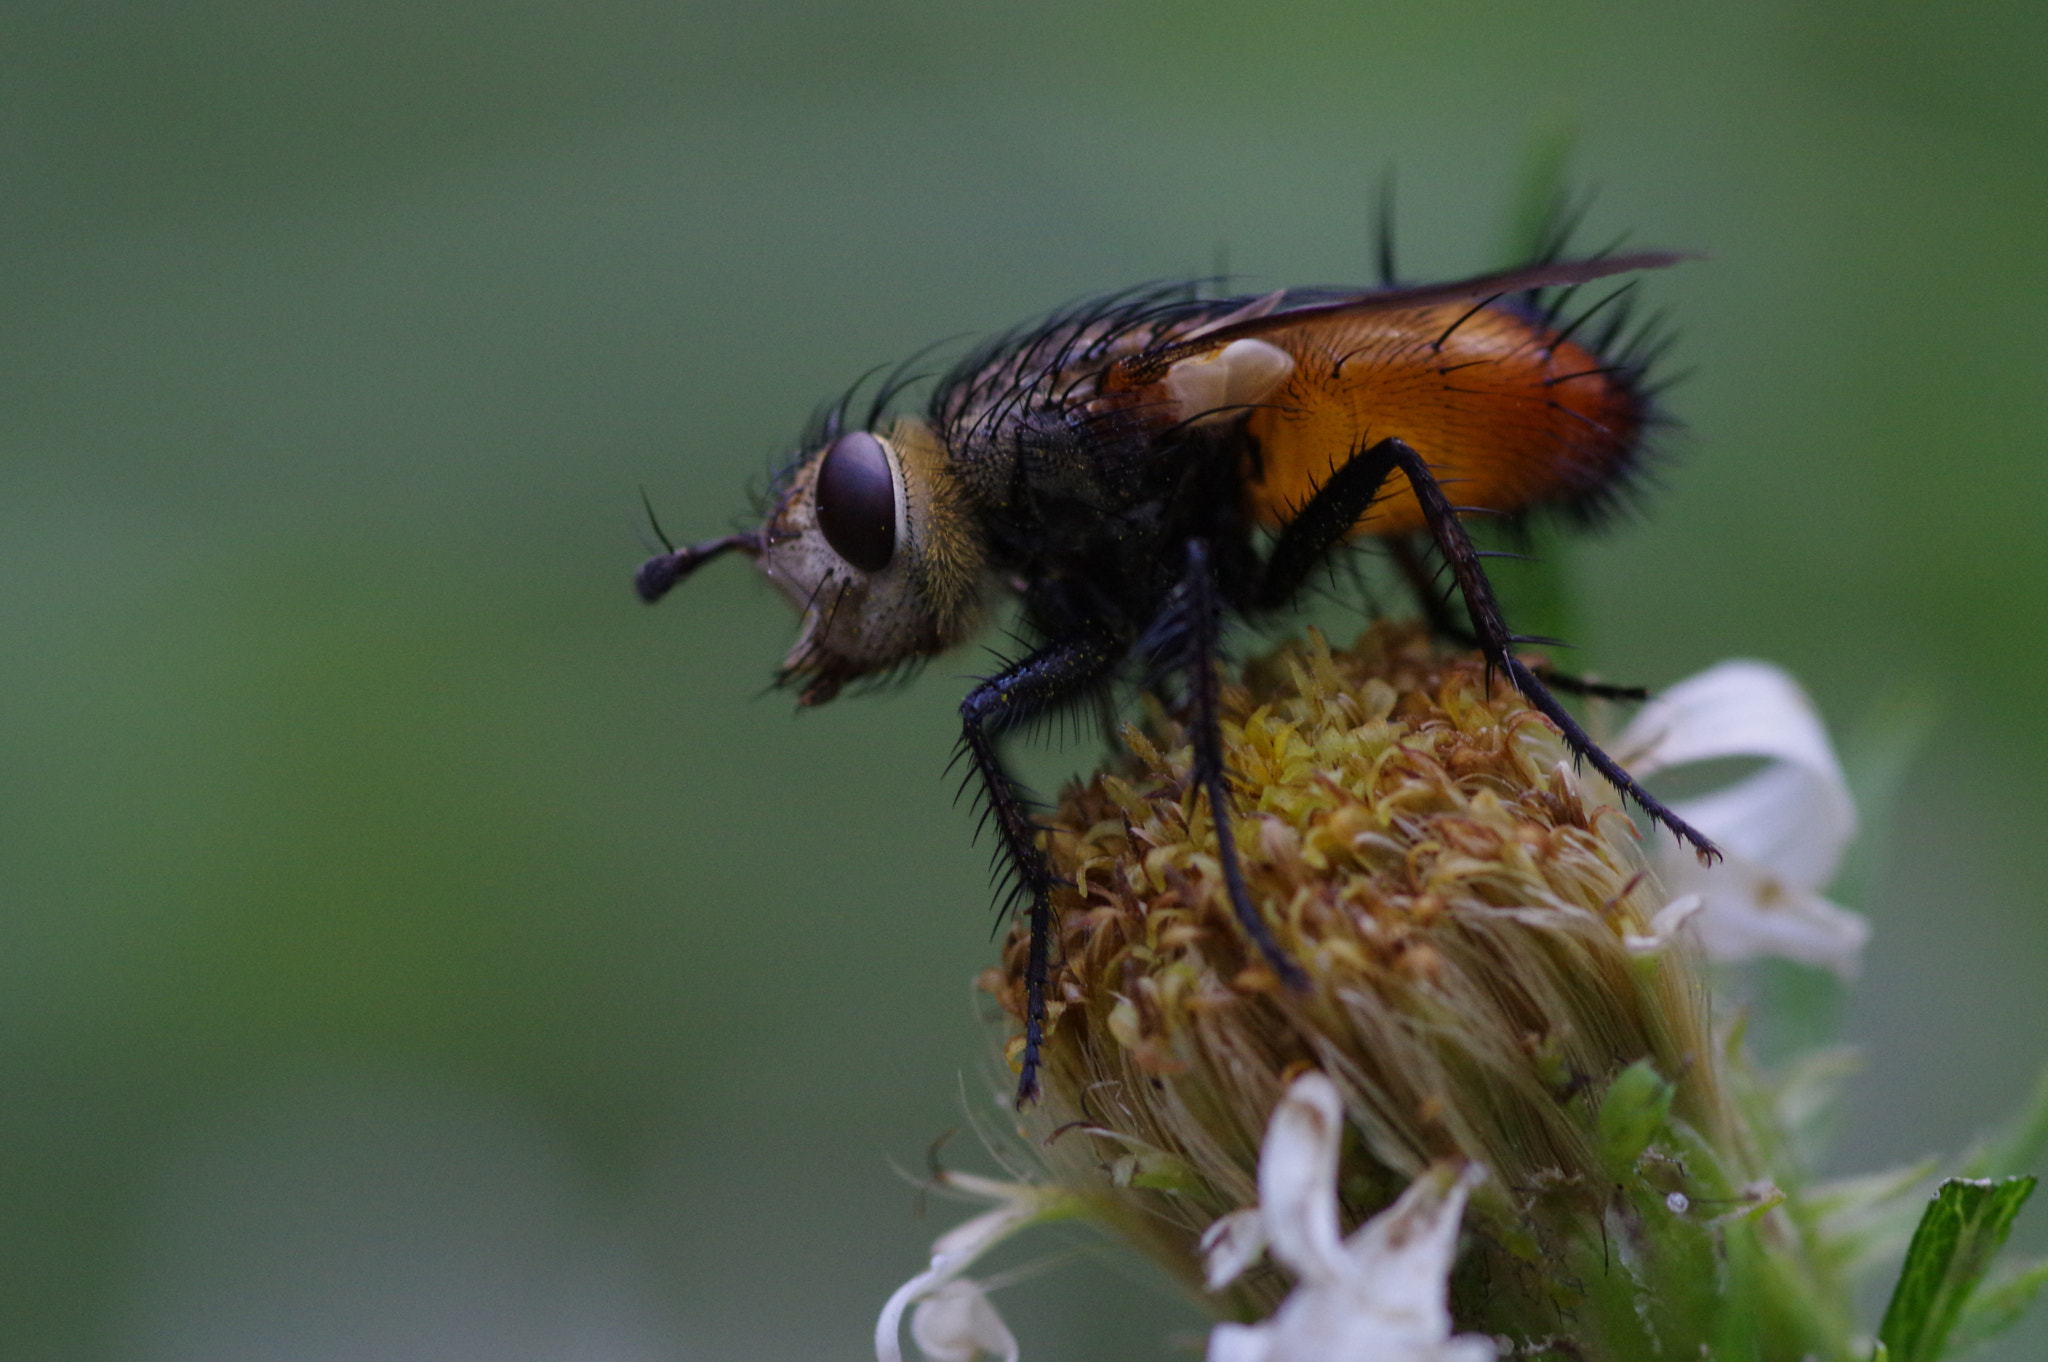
[983, 625, 1741, 1317]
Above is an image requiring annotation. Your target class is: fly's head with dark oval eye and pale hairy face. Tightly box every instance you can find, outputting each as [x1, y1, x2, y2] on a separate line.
[756, 418, 989, 705]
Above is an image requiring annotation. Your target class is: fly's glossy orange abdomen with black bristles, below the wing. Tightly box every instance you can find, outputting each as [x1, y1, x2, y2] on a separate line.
[1245, 303, 1647, 535]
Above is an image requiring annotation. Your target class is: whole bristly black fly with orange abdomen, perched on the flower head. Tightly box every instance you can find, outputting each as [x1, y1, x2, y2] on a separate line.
[637, 254, 1716, 1102]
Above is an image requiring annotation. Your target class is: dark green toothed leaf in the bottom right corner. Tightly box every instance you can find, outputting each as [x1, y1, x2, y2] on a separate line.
[1878, 1178, 2034, 1362]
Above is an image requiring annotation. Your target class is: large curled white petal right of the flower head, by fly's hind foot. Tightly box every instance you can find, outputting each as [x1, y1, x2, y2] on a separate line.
[1614, 662, 1870, 975]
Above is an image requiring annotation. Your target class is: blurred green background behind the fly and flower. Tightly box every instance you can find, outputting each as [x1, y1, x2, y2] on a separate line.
[0, 0, 2048, 1362]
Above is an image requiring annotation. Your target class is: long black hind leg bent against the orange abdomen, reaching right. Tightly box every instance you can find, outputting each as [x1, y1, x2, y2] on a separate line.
[1257, 438, 1720, 860]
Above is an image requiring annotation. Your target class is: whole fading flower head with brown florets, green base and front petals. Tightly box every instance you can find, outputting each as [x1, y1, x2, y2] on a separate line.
[985, 625, 1859, 1362]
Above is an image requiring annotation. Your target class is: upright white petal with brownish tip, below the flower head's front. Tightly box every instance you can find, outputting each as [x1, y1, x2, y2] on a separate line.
[1260, 1073, 1343, 1282]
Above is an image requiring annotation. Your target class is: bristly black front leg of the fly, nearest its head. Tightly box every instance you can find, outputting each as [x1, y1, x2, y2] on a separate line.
[961, 633, 1122, 1106]
